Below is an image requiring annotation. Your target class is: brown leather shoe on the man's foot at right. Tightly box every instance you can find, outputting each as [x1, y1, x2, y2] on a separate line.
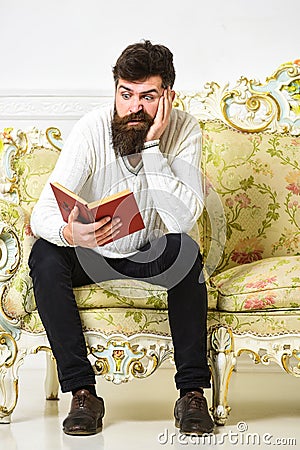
[174, 391, 214, 435]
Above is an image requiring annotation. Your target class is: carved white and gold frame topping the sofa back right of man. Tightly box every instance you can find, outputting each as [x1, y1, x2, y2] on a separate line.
[174, 60, 300, 135]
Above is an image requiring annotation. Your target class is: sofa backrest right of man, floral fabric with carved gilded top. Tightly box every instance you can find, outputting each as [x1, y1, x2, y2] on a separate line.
[177, 61, 300, 276]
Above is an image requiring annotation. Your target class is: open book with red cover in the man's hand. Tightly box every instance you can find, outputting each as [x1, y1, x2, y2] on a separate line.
[50, 182, 145, 244]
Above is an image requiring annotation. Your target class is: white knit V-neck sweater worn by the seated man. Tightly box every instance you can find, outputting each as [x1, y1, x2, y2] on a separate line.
[31, 105, 203, 258]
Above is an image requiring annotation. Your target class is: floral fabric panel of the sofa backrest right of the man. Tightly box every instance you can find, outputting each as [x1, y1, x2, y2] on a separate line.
[202, 122, 300, 272]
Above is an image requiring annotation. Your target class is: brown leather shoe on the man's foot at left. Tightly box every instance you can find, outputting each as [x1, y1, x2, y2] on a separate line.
[63, 389, 105, 435]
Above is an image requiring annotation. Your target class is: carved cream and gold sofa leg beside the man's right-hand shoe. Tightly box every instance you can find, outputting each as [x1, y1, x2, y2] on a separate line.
[208, 327, 236, 425]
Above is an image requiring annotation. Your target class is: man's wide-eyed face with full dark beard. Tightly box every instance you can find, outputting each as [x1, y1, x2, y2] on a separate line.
[112, 76, 164, 156]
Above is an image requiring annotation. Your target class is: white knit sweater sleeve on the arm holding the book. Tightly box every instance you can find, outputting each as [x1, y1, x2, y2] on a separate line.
[30, 114, 91, 246]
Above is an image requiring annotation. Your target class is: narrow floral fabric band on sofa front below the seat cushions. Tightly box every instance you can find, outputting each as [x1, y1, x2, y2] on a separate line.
[21, 308, 299, 336]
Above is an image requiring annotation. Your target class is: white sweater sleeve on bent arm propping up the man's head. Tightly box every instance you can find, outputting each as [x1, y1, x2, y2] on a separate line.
[142, 114, 203, 233]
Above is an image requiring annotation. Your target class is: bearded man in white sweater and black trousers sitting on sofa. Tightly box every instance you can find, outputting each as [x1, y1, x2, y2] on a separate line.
[29, 41, 213, 435]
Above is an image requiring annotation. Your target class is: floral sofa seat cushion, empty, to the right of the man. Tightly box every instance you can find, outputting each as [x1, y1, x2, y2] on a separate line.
[211, 256, 300, 311]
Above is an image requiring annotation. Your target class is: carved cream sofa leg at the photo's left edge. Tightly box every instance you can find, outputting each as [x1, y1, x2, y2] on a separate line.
[0, 332, 26, 423]
